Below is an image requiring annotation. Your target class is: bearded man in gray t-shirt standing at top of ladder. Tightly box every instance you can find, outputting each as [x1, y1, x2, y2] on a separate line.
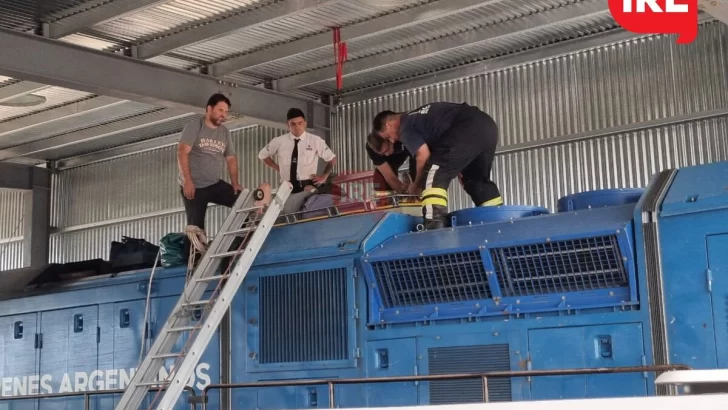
[177, 94, 243, 242]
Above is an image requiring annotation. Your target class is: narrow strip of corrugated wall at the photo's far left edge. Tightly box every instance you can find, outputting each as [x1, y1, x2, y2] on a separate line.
[0, 189, 24, 270]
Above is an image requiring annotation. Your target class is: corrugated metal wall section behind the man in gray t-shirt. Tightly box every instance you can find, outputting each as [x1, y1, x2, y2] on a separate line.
[51, 127, 285, 263]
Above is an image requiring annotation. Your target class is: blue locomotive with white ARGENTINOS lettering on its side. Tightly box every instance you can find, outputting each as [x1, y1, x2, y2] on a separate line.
[0, 162, 728, 410]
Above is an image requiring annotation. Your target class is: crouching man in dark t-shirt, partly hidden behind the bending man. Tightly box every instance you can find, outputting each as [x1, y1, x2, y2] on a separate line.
[366, 137, 417, 196]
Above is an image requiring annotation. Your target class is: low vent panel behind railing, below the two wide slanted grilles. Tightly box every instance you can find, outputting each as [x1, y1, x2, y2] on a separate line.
[427, 344, 512, 405]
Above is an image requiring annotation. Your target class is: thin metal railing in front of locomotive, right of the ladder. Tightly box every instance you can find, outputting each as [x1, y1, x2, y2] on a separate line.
[202, 364, 692, 410]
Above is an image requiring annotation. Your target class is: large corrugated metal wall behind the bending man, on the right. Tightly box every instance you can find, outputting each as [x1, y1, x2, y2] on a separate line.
[332, 23, 728, 210]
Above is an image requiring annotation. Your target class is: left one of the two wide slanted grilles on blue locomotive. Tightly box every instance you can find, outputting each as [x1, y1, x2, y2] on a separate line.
[372, 251, 491, 308]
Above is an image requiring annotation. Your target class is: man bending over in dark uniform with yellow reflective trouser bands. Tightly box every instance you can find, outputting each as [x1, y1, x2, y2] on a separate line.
[368, 102, 503, 229]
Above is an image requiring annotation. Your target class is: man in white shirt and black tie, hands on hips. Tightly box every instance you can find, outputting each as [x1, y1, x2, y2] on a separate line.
[258, 108, 336, 213]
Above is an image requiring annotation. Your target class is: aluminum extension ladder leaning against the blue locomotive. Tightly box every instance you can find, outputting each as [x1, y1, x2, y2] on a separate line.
[116, 182, 292, 410]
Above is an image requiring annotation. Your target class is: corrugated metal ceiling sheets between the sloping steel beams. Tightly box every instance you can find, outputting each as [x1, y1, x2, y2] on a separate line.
[0, 0, 636, 163]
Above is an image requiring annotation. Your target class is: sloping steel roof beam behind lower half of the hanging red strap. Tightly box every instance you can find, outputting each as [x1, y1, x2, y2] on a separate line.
[275, 0, 609, 91]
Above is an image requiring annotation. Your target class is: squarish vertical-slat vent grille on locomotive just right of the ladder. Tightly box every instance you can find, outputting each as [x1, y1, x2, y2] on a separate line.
[259, 268, 349, 364]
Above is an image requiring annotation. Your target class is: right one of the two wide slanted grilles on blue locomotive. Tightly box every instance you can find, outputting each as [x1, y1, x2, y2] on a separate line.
[490, 235, 628, 296]
